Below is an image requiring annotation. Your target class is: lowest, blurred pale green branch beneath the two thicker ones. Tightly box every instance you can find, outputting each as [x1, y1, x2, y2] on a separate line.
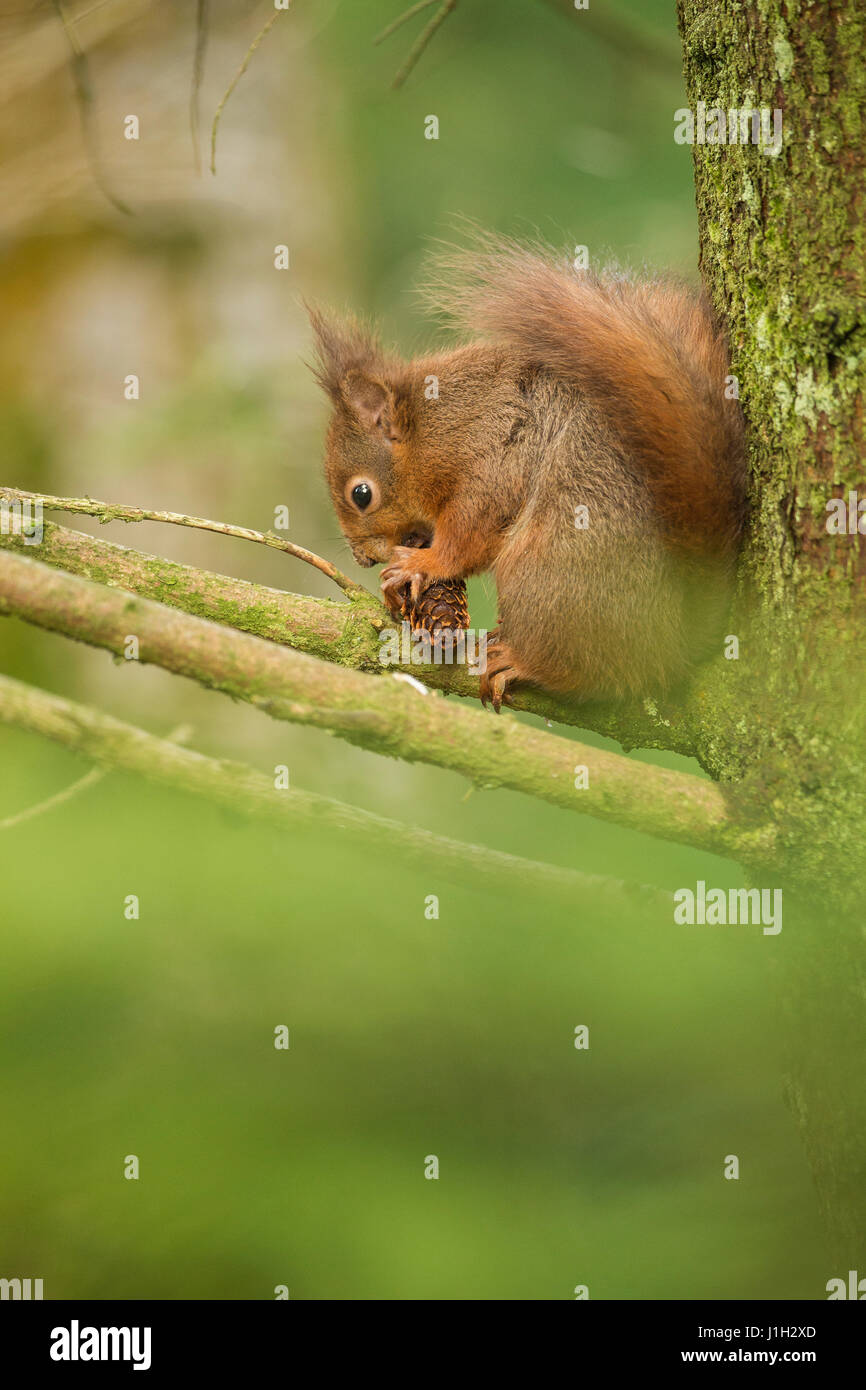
[0, 676, 673, 920]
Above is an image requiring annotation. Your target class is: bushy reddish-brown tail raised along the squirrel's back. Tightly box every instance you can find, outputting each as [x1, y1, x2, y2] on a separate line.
[424, 234, 745, 556]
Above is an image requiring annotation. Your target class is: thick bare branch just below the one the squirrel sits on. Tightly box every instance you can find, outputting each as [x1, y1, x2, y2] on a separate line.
[0, 552, 756, 858]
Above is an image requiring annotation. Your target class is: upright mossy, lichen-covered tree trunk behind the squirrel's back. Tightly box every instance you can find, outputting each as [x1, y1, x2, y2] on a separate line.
[678, 0, 866, 1277]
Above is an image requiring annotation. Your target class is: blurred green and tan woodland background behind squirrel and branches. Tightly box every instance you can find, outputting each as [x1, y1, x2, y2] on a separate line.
[0, 0, 833, 1298]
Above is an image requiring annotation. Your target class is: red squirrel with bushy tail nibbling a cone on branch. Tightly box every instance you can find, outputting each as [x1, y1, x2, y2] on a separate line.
[310, 238, 746, 710]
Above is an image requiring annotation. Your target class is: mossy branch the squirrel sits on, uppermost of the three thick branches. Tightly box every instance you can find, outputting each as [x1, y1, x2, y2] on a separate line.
[0, 521, 703, 758]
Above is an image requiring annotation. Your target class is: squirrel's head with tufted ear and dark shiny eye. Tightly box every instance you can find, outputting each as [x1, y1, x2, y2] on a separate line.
[309, 309, 432, 566]
